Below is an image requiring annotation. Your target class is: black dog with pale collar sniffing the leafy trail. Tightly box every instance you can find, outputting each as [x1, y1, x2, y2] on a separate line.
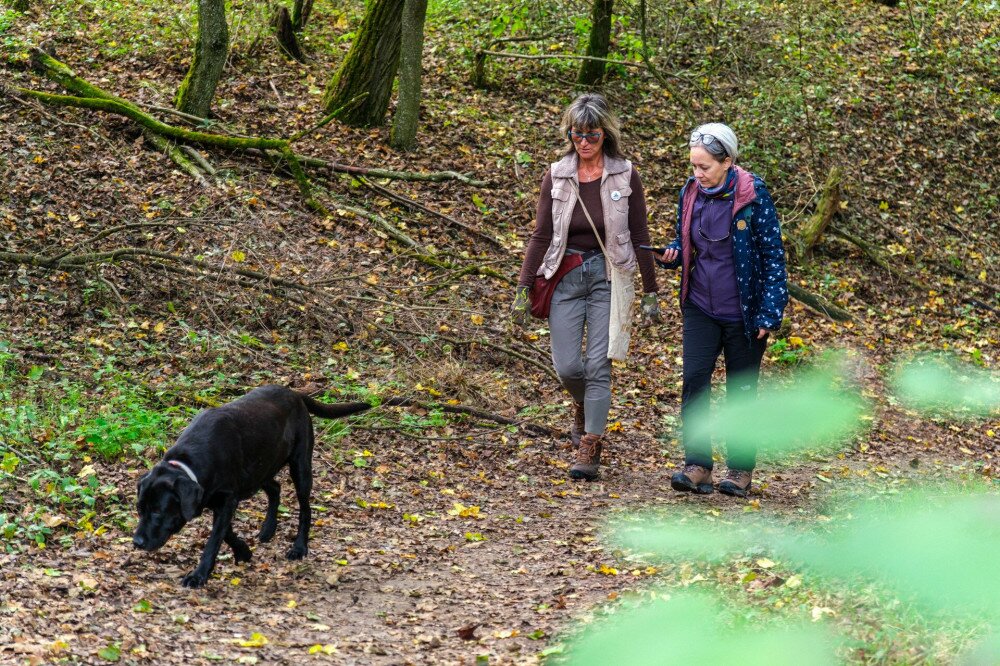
[132, 386, 371, 587]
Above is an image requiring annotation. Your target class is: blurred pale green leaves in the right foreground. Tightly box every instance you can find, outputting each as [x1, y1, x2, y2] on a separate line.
[566, 356, 1000, 665]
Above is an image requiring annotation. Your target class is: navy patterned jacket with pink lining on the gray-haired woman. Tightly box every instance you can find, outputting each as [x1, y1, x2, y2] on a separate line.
[657, 166, 788, 341]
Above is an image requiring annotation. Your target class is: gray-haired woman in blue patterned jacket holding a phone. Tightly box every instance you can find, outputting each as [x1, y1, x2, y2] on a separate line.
[657, 123, 788, 497]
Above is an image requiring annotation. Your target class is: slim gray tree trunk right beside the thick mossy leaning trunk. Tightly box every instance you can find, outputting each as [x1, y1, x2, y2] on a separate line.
[390, 0, 427, 150]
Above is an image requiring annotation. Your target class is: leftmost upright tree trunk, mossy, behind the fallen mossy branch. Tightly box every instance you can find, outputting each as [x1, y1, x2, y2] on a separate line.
[176, 0, 229, 118]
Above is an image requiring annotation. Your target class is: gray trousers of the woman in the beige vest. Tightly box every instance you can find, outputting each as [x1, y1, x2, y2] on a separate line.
[549, 254, 611, 435]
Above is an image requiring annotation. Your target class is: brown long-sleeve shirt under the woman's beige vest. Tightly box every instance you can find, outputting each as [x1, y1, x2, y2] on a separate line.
[517, 168, 657, 294]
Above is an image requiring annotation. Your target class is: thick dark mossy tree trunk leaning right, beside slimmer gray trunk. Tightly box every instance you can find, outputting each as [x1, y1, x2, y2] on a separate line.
[323, 0, 403, 127]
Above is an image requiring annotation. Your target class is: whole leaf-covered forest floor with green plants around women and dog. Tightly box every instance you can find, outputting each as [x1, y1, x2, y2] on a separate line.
[0, 0, 1000, 664]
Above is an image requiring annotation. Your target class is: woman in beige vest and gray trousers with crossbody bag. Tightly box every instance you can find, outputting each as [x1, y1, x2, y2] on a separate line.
[513, 93, 660, 480]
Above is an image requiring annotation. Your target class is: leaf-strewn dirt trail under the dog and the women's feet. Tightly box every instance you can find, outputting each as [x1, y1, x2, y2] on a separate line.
[0, 392, 991, 664]
